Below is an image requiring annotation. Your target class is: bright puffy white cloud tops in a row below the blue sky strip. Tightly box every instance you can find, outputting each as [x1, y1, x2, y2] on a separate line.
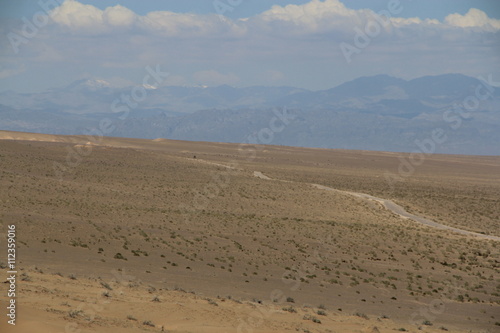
[48, 0, 500, 38]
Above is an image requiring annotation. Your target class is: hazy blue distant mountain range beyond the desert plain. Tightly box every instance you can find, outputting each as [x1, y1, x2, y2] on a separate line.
[0, 74, 500, 155]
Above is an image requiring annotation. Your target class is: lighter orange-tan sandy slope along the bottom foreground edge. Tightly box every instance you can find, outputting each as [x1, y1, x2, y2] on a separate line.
[0, 270, 465, 333]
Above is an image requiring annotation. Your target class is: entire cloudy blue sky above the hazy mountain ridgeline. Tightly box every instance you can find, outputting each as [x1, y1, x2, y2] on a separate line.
[0, 0, 500, 92]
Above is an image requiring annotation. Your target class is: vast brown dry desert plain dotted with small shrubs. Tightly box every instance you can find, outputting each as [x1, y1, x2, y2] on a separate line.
[0, 131, 500, 332]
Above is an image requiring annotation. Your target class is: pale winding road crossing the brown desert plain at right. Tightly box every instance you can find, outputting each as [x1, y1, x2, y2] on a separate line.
[253, 171, 500, 241]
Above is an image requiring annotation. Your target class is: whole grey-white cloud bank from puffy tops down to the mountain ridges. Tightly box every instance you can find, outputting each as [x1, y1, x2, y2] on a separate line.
[0, 0, 500, 89]
